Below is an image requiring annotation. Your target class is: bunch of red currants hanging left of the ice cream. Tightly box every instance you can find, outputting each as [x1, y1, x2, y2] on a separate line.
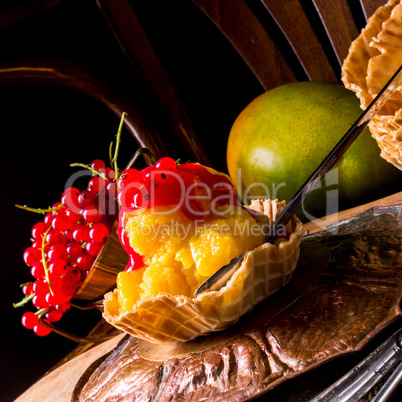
[14, 159, 118, 336]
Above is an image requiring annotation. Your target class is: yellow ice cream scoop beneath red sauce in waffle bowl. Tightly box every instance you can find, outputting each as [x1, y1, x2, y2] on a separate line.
[117, 205, 267, 313]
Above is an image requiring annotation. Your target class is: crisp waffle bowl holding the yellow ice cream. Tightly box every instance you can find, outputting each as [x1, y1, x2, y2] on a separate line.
[103, 200, 303, 343]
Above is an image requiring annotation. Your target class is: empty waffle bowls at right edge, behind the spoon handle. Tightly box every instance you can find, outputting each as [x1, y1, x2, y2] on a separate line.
[342, 0, 402, 170]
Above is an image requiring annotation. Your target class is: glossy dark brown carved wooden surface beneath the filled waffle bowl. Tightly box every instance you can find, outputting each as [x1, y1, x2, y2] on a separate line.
[73, 207, 402, 401]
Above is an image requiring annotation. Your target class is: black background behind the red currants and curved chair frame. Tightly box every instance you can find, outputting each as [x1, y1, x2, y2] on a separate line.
[0, 0, 402, 401]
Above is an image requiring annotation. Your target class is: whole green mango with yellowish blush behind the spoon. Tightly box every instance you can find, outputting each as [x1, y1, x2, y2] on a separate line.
[227, 82, 402, 219]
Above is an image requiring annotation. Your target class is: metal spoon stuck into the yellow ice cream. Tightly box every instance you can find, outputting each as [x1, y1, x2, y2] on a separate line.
[194, 65, 402, 297]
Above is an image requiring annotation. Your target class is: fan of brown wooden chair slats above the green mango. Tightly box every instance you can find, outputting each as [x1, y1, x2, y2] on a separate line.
[193, 0, 386, 90]
